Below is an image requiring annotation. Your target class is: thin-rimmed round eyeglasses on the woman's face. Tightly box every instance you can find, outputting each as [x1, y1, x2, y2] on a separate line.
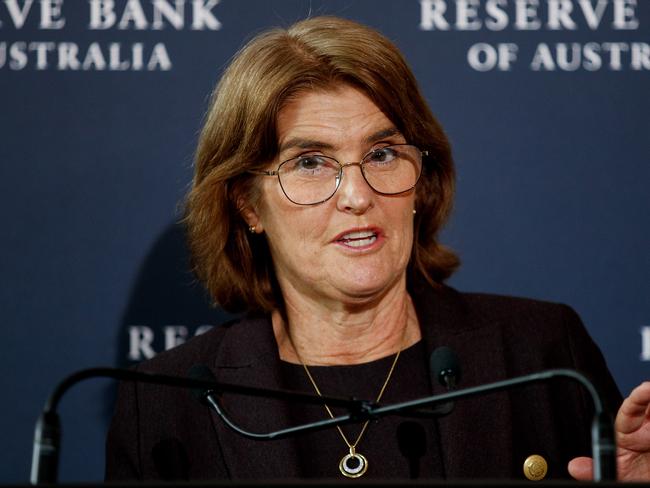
[249, 144, 429, 205]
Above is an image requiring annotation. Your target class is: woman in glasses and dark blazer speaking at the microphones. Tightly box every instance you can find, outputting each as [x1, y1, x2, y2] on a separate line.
[107, 17, 650, 479]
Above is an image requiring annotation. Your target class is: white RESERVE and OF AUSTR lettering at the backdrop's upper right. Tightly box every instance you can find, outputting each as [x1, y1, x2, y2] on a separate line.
[419, 0, 650, 72]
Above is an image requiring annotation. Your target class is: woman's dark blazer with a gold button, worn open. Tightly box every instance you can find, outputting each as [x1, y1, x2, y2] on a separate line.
[106, 287, 621, 480]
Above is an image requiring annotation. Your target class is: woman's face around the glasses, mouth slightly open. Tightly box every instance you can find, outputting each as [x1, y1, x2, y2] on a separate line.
[244, 85, 415, 304]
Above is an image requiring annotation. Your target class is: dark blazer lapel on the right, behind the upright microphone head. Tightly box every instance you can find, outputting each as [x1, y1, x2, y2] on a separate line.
[412, 285, 512, 479]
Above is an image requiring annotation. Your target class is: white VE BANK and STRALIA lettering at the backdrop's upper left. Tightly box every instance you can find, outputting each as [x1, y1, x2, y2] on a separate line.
[0, 0, 222, 71]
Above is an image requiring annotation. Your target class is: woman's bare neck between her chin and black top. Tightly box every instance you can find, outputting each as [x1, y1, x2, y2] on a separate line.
[272, 280, 421, 366]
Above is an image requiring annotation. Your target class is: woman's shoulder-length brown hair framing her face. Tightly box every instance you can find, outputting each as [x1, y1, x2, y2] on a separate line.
[185, 17, 459, 312]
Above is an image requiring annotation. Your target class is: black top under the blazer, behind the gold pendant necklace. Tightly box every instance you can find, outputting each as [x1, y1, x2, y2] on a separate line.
[281, 341, 442, 479]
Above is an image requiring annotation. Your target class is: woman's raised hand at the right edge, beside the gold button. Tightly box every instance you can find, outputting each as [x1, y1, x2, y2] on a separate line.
[569, 381, 650, 481]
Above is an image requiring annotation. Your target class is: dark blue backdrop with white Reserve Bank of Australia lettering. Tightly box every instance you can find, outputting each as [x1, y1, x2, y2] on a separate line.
[0, 0, 650, 482]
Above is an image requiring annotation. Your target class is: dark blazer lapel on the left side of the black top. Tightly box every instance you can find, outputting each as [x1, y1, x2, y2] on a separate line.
[206, 318, 301, 479]
